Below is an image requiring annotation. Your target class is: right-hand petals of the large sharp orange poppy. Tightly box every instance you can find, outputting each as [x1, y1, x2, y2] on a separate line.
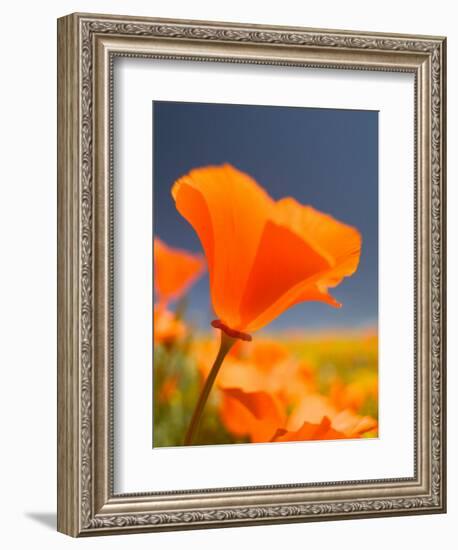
[242, 198, 361, 332]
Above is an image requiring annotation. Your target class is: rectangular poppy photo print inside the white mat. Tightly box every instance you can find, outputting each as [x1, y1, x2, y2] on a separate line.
[153, 101, 378, 448]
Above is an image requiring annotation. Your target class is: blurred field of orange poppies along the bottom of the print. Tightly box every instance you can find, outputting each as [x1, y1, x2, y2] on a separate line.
[153, 308, 378, 447]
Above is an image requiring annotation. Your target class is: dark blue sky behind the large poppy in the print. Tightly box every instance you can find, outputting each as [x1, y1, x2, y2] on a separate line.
[153, 101, 378, 330]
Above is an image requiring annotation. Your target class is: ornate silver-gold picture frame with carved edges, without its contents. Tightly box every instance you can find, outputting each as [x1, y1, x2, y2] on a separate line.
[58, 14, 446, 536]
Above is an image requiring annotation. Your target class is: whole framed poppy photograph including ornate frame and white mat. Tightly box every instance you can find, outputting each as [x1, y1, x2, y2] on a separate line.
[58, 14, 446, 536]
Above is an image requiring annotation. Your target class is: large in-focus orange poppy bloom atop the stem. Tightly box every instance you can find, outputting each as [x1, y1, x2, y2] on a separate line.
[172, 164, 361, 339]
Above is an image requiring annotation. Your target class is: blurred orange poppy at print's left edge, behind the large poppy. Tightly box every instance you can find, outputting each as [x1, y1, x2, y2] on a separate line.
[154, 237, 205, 303]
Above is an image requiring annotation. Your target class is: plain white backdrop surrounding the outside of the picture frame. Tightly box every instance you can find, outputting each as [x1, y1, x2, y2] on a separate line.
[0, 0, 452, 550]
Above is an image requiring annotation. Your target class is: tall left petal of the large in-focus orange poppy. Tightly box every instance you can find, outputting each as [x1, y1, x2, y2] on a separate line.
[172, 164, 275, 328]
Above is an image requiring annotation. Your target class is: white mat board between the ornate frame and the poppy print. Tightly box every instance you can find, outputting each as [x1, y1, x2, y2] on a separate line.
[114, 58, 414, 493]
